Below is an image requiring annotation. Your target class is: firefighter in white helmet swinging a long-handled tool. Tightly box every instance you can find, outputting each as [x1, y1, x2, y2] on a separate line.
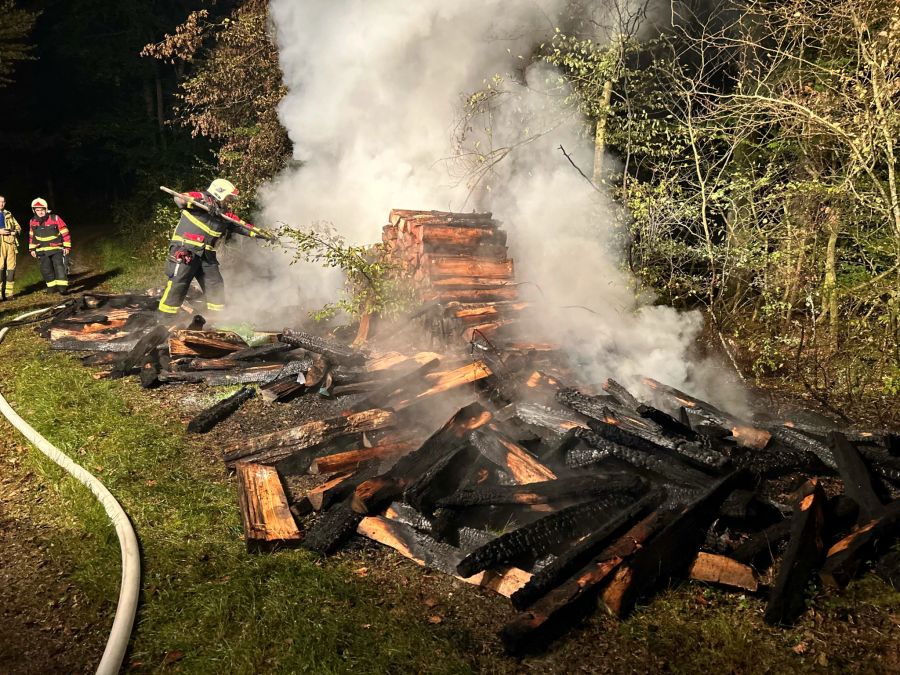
[159, 178, 271, 315]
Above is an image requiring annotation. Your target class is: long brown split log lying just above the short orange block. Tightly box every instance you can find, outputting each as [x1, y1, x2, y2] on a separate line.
[223, 409, 394, 467]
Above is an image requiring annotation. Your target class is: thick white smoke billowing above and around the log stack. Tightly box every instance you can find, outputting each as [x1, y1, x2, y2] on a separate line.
[223, 0, 735, 418]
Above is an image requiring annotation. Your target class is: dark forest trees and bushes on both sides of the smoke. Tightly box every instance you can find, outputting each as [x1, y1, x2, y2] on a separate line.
[0, 0, 900, 423]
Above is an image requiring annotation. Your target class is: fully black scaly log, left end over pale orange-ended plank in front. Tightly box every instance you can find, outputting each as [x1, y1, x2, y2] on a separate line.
[456, 494, 635, 577]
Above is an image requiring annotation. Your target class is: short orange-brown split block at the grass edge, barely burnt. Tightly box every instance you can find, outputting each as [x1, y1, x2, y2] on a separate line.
[235, 462, 301, 552]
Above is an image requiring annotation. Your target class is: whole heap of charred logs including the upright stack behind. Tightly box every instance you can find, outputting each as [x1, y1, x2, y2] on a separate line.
[28, 230, 900, 654]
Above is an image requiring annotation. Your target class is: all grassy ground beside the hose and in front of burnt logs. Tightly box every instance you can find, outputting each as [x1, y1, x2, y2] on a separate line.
[0, 247, 900, 675]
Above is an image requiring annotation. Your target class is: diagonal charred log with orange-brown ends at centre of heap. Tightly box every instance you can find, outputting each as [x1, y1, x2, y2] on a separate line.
[352, 403, 491, 514]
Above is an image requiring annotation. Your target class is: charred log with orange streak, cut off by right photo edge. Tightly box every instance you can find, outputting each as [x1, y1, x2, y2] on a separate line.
[819, 500, 900, 587]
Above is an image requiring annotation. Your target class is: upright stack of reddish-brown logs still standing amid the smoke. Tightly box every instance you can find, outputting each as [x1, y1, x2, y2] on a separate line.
[382, 209, 522, 340]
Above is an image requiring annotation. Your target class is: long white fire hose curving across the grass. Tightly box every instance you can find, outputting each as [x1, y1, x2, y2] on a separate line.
[0, 307, 141, 675]
